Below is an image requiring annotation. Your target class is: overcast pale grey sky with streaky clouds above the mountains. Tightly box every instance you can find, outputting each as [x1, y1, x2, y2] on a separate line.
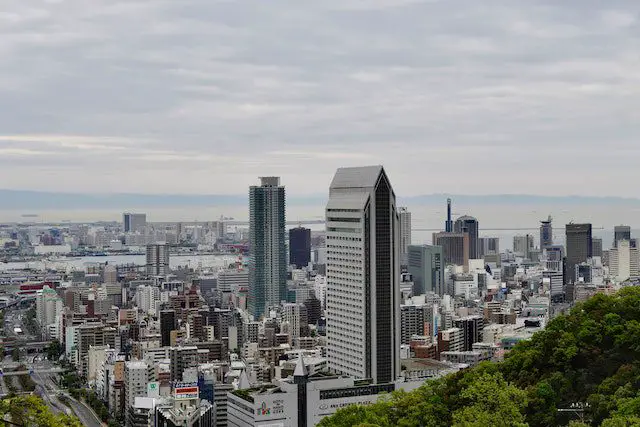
[0, 0, 640, 197]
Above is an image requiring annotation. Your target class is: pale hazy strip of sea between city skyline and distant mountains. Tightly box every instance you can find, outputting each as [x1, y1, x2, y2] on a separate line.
[0, 199, 640, 249]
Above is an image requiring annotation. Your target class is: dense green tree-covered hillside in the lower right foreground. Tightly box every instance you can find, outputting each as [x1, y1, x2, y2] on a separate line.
[320, 287, 640, 427]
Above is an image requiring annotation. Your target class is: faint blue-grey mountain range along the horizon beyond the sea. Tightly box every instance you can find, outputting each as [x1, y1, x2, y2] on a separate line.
[0, 189, 640, 210]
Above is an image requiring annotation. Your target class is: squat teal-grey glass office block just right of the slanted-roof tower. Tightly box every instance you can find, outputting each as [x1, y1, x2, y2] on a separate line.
[407, 245, 445, 295]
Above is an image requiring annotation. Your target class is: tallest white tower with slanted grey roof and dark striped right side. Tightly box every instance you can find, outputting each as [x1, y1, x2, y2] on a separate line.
[326, 166, 400, 383]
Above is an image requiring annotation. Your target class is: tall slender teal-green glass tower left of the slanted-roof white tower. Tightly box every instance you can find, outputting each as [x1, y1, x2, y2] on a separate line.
[248, 176, 287, 319]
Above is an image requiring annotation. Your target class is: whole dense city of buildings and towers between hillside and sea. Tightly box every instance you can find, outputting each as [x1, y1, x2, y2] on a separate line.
[0, 166, 624, 427]
